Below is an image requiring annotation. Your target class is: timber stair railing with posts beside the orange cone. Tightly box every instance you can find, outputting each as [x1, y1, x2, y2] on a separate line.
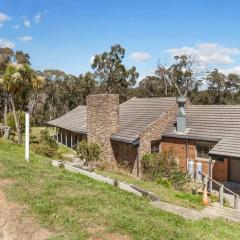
[199, 172, 239, 209]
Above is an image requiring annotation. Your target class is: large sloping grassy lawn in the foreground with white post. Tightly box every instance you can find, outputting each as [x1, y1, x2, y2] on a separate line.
[0, 140, 240, 240]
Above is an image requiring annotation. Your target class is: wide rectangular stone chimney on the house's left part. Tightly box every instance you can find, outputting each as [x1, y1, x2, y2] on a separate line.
[86, 94, 119, 161]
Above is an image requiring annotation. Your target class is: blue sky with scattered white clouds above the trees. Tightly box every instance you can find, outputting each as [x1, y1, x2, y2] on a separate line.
[0, 0, 240, 79]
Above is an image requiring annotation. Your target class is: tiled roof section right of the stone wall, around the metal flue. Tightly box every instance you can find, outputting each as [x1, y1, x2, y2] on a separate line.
[163, 105, 240, 157]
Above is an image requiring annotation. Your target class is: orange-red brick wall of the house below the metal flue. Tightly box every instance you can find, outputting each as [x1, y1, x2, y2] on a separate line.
[161, 138, 228, 182]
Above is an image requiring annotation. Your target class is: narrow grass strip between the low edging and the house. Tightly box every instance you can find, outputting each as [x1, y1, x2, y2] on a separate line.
[96, 170, 203, 210]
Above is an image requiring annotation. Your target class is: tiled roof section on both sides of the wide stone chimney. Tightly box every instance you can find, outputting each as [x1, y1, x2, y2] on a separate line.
[48, 97, 176, 142]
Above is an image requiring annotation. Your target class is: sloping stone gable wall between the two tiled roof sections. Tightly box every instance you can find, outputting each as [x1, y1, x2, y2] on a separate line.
[133, 103, 177, 175]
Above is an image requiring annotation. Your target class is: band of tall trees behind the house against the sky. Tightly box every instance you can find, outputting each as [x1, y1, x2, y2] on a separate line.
[0, 47, 240, 130]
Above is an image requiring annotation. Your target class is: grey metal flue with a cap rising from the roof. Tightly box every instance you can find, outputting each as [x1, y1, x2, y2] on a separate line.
[177, 97, 187, 133]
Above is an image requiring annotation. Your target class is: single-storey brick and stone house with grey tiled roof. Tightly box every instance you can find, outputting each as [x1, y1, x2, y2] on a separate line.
[48, 94, 240, 183]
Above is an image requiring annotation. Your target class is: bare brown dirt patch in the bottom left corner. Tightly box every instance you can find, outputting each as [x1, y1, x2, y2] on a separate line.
[0, 179, 51, 240]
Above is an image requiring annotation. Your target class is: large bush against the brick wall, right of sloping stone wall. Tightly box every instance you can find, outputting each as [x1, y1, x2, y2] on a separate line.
[141, 150, 188, 189]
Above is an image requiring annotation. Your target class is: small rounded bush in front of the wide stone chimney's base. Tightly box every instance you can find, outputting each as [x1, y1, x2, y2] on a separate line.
[76, 140, 101, 165]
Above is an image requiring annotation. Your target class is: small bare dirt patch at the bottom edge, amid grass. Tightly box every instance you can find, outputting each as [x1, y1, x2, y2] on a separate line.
[87, 226, 131, 240]
